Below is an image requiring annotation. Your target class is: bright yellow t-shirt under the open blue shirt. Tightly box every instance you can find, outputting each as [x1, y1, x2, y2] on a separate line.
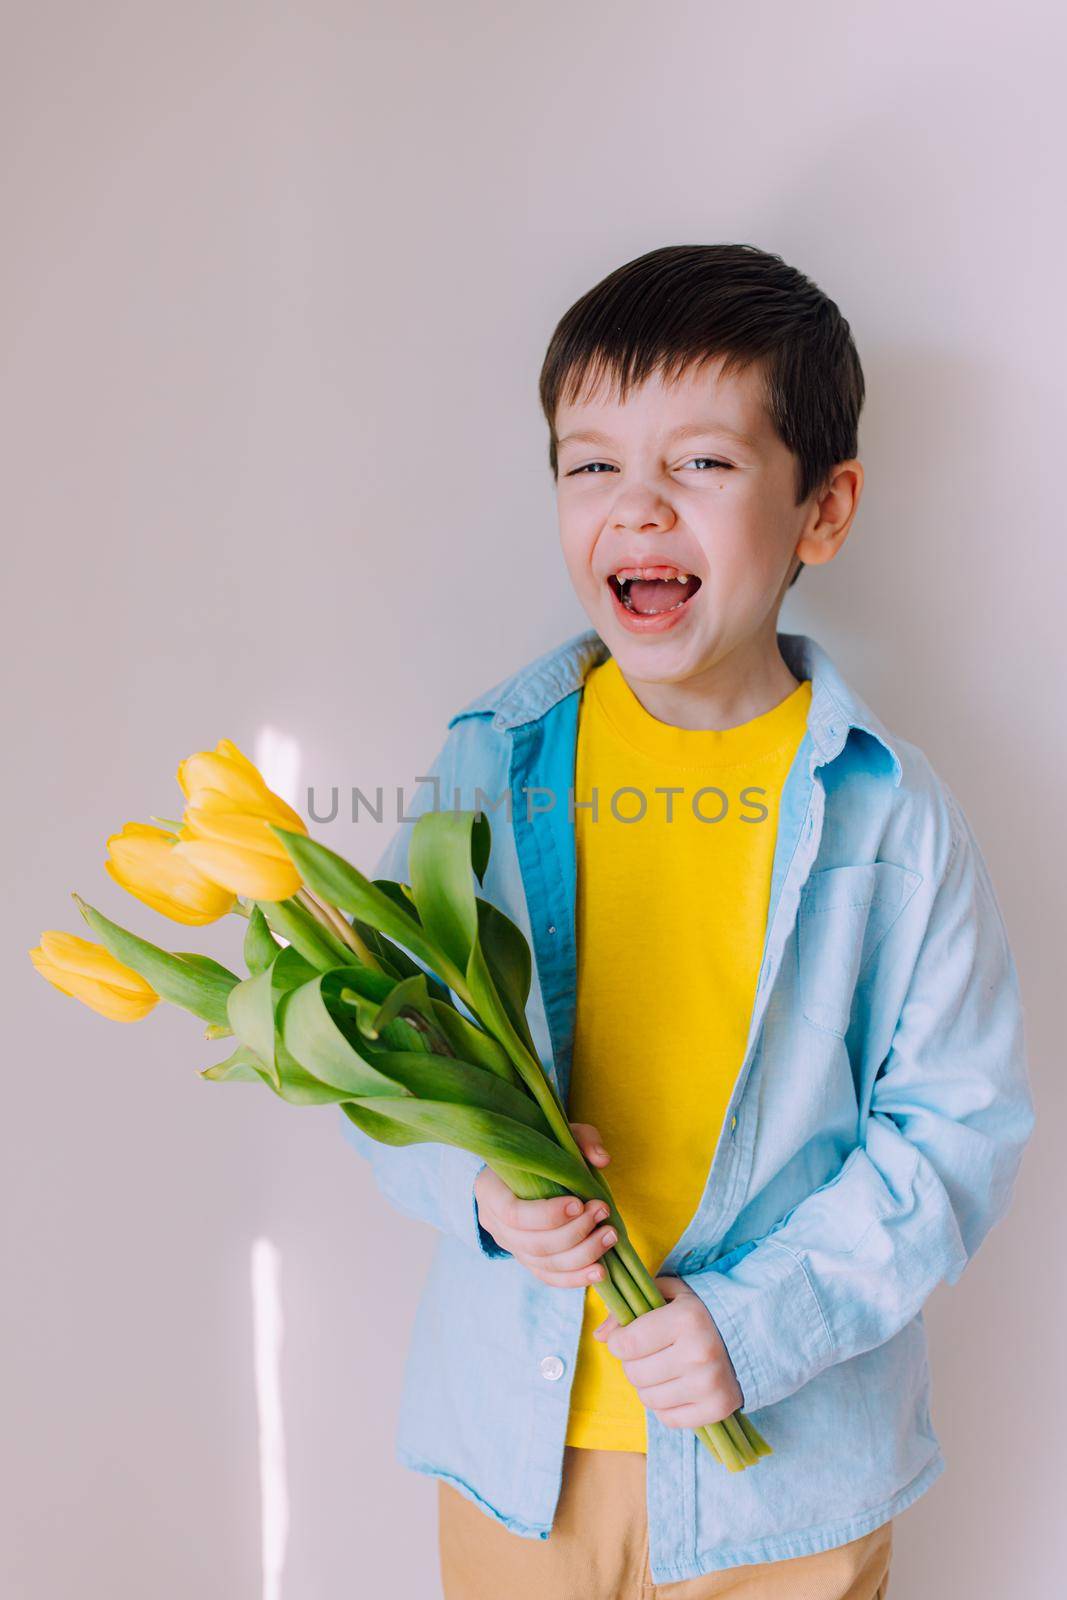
[566, 656, 811, 1451]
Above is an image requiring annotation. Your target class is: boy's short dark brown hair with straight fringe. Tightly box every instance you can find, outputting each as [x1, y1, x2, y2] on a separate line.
[539, 245, 864, 584]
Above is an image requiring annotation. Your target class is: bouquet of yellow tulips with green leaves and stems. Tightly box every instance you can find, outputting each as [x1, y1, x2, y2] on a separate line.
[30, 739, 769, 1472]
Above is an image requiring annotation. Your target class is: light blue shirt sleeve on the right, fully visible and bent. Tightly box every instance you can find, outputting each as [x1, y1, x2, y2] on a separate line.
[681, 786, 1033, 1411]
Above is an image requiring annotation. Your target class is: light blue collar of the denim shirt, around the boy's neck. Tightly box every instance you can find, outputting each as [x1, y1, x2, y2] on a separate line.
[448, 627, 902, 786]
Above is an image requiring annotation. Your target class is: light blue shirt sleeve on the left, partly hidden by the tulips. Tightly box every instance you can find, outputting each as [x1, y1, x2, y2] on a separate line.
[341, 738, 514, 1261]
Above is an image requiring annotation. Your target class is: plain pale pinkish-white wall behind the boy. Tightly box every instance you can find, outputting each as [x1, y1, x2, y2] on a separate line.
[0, 0, 1067, 1600]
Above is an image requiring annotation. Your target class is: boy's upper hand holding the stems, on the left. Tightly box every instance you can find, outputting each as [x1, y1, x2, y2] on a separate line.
[474, 1122, 616, 1288]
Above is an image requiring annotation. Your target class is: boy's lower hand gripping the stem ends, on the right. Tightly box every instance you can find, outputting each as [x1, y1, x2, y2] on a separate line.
[593, 1277, 744, 1427]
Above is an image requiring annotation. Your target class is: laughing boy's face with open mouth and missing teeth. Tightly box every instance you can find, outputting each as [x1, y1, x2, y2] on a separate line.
[555, 362, 862, 683]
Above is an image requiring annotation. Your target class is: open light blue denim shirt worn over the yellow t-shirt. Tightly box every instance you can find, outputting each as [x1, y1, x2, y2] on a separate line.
[344, 630, 1033, 1584]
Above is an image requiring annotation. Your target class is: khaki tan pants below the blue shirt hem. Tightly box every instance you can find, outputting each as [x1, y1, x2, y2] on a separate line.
[437, 1445, 893, 1600]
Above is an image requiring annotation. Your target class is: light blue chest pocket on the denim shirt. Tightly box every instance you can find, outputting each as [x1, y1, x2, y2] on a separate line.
[797, 861, 923, 1038]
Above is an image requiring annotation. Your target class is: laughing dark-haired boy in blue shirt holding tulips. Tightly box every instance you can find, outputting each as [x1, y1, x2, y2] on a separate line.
[346, 245, 1033, 1600]
